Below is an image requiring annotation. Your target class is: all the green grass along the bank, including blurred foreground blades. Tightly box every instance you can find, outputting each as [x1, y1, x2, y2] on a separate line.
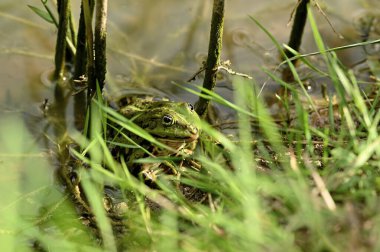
[0, 1, 380, 251]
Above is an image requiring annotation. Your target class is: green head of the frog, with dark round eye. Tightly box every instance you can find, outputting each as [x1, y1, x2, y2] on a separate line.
[124, 101, 199, 142]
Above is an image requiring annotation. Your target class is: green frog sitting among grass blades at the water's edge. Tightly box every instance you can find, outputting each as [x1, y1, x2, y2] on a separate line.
[110, 98, 200, 181]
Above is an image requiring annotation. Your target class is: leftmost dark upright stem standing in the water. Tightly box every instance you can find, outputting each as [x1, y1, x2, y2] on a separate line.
[54, 0, 70, 80]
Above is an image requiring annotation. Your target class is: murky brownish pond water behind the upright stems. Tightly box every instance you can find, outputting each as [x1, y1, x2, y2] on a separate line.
[0, 0, 379, 150]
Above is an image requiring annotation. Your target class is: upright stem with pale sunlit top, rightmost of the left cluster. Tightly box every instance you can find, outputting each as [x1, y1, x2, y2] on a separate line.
[95, 0, 107, 90]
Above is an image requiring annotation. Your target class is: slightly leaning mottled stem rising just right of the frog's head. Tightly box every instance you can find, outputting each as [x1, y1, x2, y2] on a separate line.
[195, 0, 224, 116]
